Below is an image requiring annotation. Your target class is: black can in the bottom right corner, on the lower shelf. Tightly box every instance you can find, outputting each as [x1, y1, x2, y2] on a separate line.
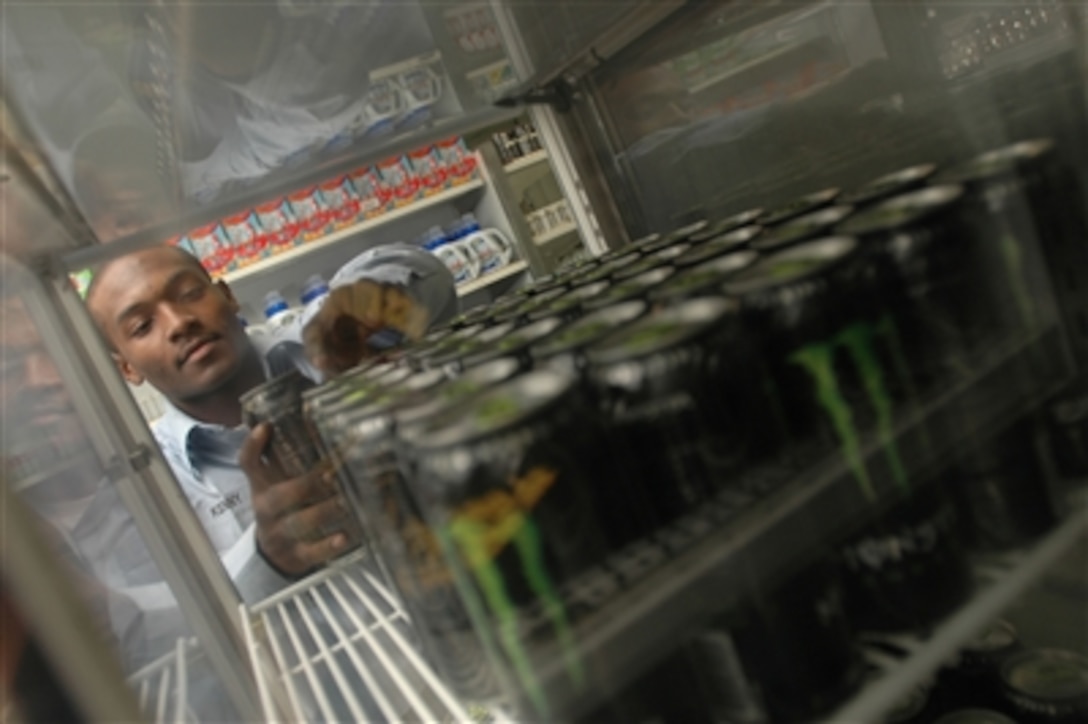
[1001, 649, 1088, 724]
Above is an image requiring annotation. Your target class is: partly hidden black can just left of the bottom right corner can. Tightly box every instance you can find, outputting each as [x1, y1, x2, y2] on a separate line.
[940, 619, 1024, 709]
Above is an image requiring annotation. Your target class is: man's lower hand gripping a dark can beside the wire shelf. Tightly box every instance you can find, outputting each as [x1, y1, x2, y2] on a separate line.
[238, 425, 359, 577]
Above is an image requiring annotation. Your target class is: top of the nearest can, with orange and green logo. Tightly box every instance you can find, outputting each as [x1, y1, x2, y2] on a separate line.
[406, 370, 574, 450]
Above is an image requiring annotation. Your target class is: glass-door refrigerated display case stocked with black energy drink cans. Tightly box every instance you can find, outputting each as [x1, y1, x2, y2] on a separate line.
[2, 0, 1088, 724]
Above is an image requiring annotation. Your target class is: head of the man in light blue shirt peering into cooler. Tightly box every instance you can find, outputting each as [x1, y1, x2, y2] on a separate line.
[88, 247, 249, 402]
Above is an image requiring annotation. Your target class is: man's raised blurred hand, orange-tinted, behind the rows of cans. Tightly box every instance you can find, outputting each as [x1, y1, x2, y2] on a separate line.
[302, 280, 429, 377]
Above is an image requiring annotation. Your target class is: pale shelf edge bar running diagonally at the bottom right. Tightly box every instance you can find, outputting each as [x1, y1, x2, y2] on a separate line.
[827, 507, 1088, 722]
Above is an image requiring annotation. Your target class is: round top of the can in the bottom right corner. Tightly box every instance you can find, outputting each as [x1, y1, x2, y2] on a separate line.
[1001, 649, 1088, 703]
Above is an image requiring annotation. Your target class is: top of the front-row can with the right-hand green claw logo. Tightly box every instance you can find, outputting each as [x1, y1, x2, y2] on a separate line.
[722, 236, 857, 297]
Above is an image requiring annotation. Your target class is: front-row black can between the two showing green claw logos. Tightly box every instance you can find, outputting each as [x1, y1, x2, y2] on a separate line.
[586, 297, 749, 520]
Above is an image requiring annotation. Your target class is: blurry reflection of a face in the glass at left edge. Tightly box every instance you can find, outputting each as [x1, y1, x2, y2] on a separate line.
[0, 298, 88, 454]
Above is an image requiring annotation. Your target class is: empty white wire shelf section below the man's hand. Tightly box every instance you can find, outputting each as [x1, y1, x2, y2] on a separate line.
[246, 551, 505, 723]
